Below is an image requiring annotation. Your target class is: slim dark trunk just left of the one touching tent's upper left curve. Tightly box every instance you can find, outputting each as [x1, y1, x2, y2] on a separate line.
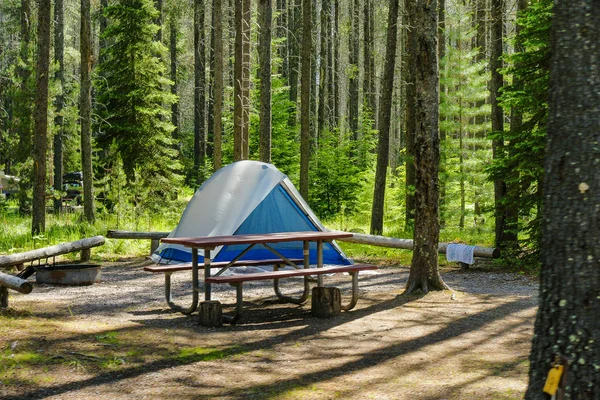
[194, 0, 206, 186]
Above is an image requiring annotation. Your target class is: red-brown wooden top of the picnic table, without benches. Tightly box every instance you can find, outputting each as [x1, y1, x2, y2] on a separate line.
[161, 231, 353, 248]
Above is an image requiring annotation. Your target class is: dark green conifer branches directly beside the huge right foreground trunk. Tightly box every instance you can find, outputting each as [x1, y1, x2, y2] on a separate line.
[488, 0, 553, 268]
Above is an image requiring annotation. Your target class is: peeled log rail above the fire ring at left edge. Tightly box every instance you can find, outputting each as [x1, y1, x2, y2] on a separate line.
[0, 236, 106, 267]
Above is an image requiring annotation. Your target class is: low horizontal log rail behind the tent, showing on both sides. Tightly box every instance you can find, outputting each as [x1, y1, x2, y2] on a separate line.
[106, 230, 500, 258]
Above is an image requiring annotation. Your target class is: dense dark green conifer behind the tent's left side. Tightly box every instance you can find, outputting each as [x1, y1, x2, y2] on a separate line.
[96, 0, 180, 192]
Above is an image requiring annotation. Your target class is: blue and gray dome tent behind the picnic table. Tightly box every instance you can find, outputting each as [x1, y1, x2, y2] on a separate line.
[152, 161, 352, 265]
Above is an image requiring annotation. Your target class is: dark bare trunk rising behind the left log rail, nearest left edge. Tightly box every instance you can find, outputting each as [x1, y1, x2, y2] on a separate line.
[31, 0, 51, 235]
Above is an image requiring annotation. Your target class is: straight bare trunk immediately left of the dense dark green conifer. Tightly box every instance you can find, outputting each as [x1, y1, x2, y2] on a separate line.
[79, 0, 95, 223]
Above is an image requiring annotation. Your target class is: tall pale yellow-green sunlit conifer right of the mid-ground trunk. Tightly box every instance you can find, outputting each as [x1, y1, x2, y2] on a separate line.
[440, 5, 493, 228]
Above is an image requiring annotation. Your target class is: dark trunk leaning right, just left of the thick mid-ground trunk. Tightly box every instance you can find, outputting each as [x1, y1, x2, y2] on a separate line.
[365, 0, 398, 235]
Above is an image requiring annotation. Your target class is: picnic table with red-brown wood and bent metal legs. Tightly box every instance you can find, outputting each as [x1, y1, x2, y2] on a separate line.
[156, 231, 377, 321]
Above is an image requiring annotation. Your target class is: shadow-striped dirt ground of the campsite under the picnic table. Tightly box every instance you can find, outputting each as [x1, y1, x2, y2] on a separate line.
[0, 260, 537, 400]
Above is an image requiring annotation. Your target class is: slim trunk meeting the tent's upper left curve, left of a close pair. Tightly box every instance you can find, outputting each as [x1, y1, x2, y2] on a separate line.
[212, 0, 223, 171]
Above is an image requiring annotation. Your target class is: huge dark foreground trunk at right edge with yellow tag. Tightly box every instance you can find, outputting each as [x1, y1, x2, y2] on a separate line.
[525, 0, 600, 400]
